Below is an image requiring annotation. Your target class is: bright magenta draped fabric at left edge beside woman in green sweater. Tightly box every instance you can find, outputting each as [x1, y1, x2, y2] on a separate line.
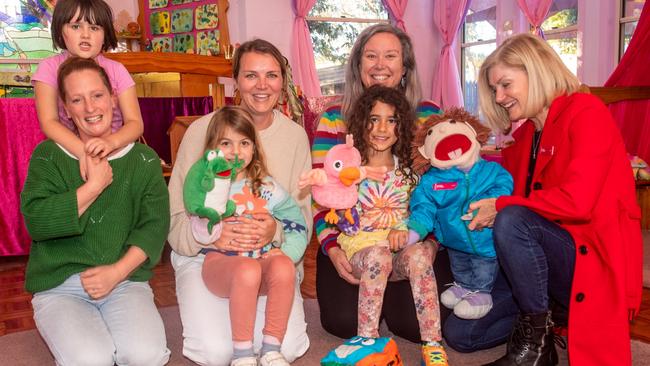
[0, 98, 45, 256]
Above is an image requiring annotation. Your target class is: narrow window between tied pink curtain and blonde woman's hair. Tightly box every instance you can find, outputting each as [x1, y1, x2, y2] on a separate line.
[460, 0, 497, 114]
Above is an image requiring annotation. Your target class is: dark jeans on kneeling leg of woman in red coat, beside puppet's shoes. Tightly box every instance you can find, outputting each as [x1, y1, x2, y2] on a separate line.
[442, 271, 519, 352]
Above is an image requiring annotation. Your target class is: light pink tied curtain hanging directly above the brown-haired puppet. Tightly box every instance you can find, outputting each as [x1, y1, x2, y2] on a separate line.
[431, 0, 471, 109]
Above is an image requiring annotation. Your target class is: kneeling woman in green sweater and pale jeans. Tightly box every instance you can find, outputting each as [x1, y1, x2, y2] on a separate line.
[21, 57, 169, 365]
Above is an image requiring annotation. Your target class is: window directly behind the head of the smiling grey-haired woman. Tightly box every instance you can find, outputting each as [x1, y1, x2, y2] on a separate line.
[307, 0, 388, 95]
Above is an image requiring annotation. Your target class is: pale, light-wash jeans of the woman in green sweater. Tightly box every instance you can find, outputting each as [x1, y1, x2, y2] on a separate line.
[32, 274, 169, 366]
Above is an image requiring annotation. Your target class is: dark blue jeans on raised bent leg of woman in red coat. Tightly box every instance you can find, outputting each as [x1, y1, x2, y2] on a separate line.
[494, 206, 576, 314]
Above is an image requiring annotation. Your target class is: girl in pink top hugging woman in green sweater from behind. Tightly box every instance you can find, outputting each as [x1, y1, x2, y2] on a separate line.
[32, 0, 144, 179]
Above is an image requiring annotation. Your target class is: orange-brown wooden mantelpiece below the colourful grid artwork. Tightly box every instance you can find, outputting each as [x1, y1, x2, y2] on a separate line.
[105, 52, 232, 109]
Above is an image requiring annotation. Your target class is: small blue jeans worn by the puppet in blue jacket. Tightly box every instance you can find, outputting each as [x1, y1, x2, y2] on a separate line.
[447, 248, 499, 293]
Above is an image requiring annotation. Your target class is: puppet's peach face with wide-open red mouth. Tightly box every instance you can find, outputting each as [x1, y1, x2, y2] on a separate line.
[418, 119, 481, 170]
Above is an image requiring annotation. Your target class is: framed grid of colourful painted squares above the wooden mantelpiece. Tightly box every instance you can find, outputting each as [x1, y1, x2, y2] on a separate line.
[143, 0, 220, 55]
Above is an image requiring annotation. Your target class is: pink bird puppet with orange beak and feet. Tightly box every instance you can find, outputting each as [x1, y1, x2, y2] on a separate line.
[298, 135, 388, 224]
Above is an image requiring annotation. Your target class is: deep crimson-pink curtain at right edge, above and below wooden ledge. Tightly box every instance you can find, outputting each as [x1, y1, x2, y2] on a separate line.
[605, 1, 650, 162]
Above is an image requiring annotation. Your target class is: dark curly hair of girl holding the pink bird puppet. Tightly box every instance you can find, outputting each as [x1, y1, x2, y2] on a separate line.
[346, 85, 417, 186]
